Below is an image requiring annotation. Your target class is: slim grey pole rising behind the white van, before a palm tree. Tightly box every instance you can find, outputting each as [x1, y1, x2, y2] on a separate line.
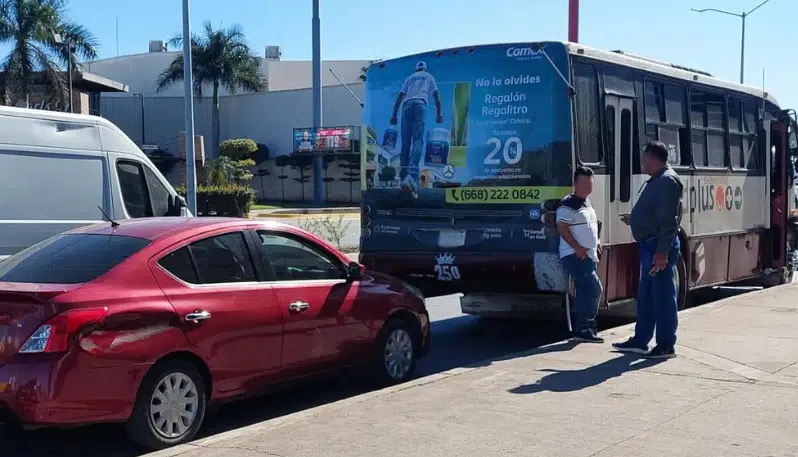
[183, 0, 197, 216]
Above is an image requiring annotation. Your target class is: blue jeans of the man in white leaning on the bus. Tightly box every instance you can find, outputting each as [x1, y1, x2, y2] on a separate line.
[560, 254, 602, 333]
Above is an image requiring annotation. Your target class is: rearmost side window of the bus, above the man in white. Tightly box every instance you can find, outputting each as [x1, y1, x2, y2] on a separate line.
[574, 63, 604, 164]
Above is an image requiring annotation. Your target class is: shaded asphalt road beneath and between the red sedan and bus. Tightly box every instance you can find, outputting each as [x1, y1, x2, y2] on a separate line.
[0, 289, 764, 457]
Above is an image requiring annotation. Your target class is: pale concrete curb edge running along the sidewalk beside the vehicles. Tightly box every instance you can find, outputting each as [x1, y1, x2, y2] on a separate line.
[141, 284, 798, 457]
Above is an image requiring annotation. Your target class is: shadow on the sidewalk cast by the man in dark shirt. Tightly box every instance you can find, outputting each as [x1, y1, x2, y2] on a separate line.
[509, 354, 664, 394]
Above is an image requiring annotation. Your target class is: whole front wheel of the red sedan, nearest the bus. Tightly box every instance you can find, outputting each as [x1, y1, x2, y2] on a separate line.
[374, 318, 421, 385]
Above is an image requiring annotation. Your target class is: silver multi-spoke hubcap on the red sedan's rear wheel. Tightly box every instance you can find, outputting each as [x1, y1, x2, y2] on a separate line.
[150, 373, 199, 439]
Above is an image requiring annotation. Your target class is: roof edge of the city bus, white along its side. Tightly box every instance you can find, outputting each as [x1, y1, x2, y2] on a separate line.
[375, 41, 779, 106]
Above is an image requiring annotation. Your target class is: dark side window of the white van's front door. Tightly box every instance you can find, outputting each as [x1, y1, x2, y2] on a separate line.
[116, 160, 170, 218]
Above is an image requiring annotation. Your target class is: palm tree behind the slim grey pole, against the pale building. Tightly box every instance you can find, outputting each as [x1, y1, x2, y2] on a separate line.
[158, 21, 266, 159]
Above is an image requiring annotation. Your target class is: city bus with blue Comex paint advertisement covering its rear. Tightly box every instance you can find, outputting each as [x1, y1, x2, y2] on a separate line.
[360, 42, 798, 317]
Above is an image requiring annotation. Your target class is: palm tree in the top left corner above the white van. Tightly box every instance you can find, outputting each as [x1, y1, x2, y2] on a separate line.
[0, 0, 98, 103]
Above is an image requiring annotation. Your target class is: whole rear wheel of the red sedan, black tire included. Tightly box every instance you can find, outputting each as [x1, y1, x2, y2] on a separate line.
[127, 360, 207, 450]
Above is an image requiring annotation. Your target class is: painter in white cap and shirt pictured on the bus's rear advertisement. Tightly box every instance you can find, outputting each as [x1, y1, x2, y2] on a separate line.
[391, 61, 443, 198]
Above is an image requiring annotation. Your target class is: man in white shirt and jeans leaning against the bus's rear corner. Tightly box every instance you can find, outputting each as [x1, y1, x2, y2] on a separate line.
[557, 166, 604, 343]
